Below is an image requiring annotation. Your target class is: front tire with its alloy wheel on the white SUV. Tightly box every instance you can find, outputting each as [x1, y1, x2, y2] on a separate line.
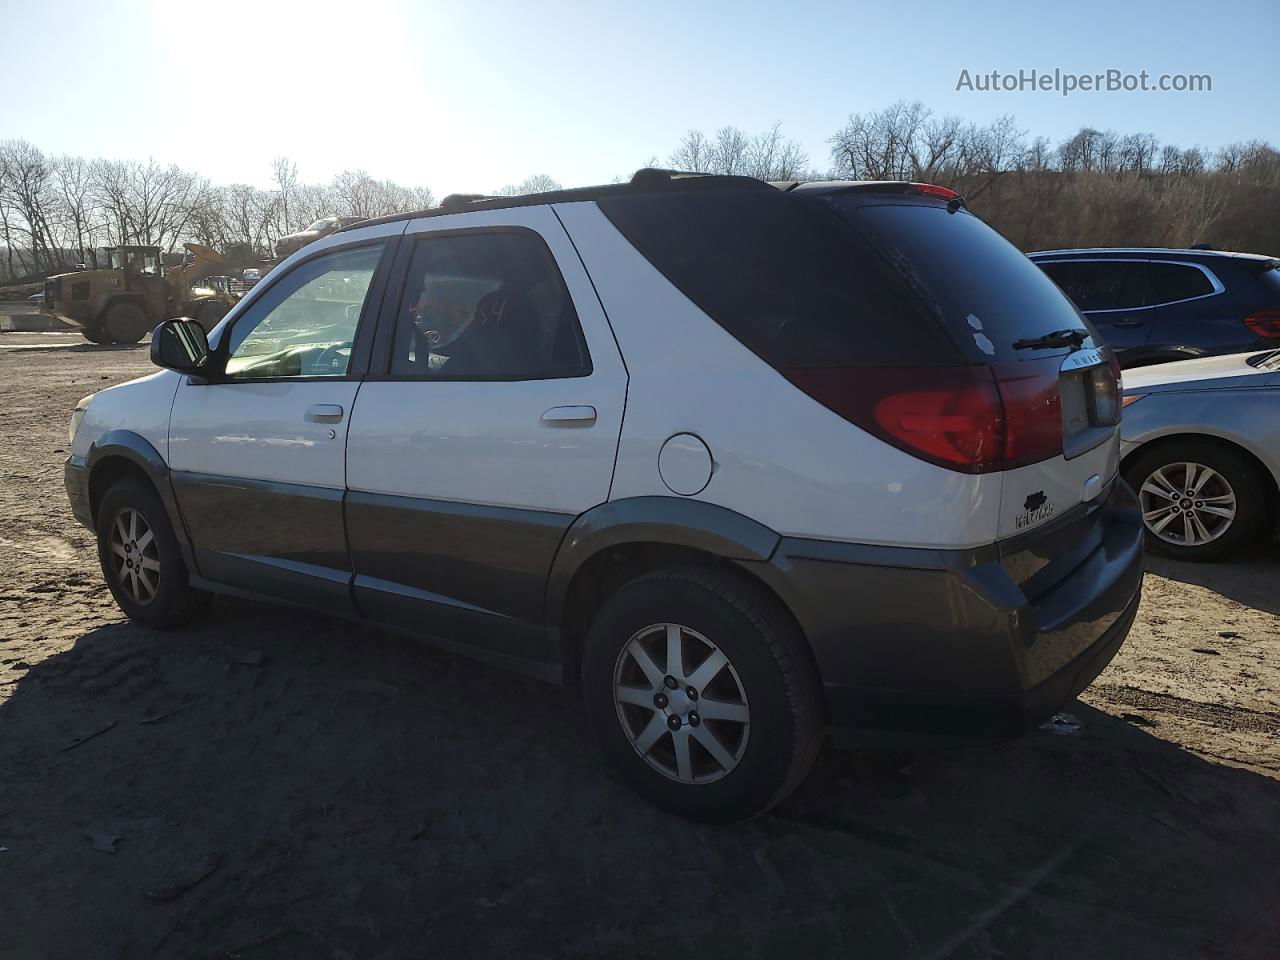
[97, 477, 210, 627]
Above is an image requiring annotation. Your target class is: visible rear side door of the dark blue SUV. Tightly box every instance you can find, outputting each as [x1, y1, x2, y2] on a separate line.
[1039, 260, 1157, 355]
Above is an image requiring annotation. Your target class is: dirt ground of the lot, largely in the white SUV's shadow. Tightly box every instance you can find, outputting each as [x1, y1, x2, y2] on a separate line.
[0, 334, 1280, 960]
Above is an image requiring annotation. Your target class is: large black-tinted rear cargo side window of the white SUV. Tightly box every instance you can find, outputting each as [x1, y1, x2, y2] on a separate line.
[598, 191, 962, 369]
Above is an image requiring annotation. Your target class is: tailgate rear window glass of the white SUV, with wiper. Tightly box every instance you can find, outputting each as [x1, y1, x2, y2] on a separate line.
[828, 203, 1088, 362]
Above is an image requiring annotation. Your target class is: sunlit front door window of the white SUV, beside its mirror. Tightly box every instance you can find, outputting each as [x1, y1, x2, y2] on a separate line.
[227, 243, 383, 380]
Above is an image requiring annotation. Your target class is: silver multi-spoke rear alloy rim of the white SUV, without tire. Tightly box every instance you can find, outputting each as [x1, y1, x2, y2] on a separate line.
[613, 623, 750, 783]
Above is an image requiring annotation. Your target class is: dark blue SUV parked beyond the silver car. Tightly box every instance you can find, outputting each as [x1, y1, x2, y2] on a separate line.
[1028, 247, 1280, 367]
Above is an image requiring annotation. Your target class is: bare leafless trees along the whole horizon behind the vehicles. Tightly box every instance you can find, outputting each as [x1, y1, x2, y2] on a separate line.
[0, 102, 1280, 285]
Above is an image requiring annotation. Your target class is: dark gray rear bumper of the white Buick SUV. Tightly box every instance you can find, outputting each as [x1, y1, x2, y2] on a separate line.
[750, 480, 1143, 746]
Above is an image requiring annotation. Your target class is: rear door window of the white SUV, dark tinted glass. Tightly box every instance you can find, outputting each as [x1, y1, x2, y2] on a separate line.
[392, 232, 591, 380]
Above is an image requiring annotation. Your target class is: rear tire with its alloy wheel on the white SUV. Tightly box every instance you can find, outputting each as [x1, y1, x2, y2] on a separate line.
[582, 567, 823, 823]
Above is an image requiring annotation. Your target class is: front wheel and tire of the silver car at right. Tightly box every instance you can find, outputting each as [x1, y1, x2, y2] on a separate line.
[1124, 439, 1274, 563]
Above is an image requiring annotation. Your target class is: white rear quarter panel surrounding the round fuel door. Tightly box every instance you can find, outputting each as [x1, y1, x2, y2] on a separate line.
[557, 202, 1001, 547]
